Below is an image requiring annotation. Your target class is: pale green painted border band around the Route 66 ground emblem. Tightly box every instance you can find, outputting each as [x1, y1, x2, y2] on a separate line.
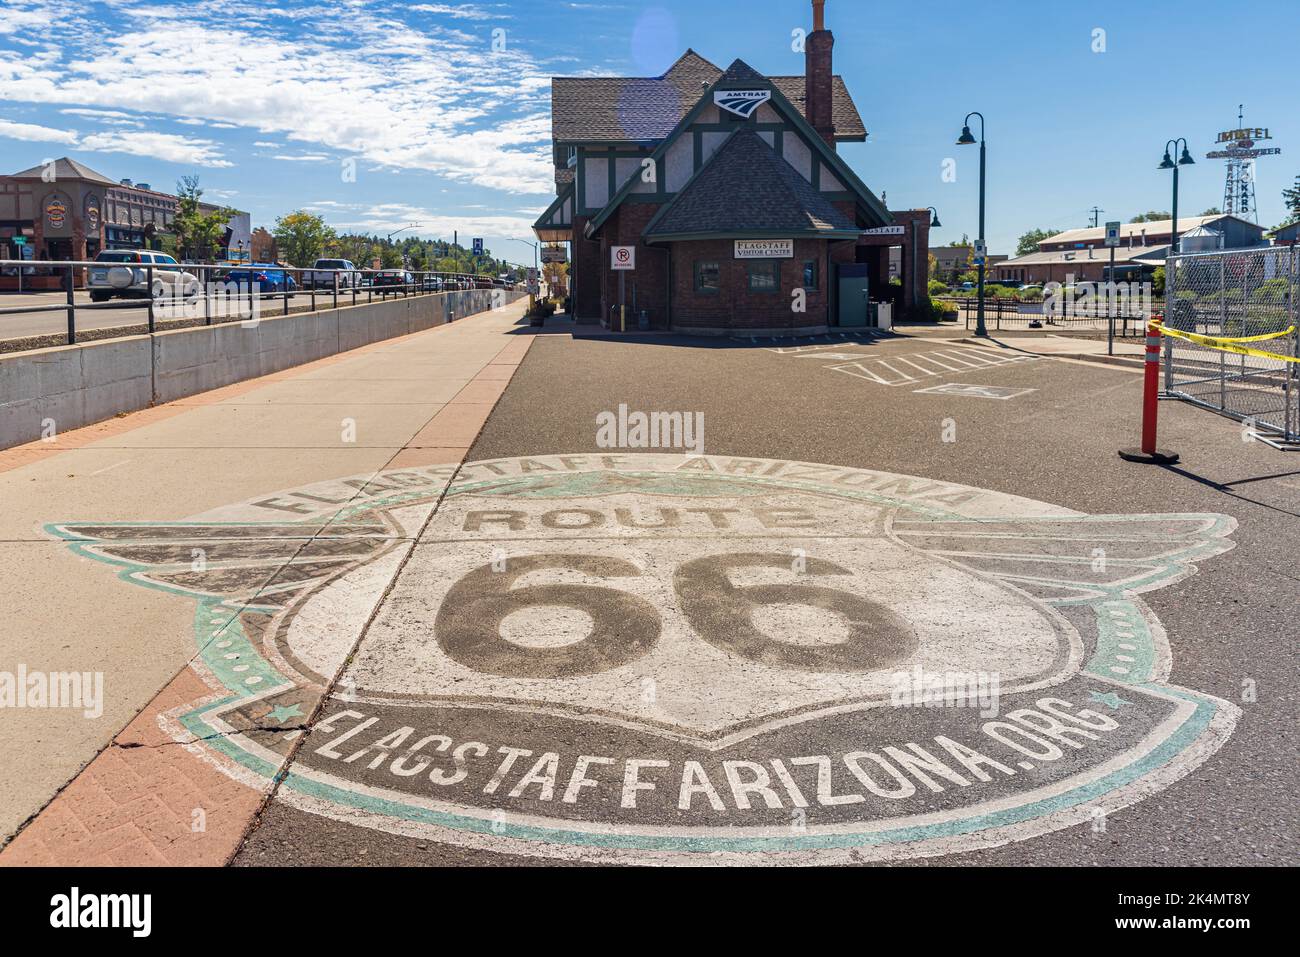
[55, 469, 1231, 853]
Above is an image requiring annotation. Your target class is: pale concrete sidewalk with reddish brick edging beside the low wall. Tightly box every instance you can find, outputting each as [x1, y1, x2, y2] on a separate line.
[0, 303, 533, 865]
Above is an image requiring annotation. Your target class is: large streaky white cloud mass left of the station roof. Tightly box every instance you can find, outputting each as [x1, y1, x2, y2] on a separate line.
[0, 0, 554, 194]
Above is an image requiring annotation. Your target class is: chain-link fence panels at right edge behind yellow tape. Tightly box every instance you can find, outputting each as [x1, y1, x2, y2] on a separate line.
[1164, 246, 1300, 443]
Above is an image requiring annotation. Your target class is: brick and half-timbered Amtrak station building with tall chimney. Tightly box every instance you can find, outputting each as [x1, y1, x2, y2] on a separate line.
[534, 0, 930, 335]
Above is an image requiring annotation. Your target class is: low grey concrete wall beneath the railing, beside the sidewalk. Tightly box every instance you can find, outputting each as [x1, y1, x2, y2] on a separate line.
[0, 289, 521, 449]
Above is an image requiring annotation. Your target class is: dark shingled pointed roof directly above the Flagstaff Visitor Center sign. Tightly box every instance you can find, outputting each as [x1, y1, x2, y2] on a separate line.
[645, 130, 862, 242]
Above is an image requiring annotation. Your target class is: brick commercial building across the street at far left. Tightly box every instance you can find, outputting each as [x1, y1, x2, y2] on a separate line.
[0, 156, 251, 283]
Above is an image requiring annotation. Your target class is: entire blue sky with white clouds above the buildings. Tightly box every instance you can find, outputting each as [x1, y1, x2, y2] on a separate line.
[0, 0, 1300, 261]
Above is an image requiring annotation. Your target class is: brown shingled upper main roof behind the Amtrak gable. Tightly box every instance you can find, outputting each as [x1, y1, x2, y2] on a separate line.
[551, 49, 867, 143]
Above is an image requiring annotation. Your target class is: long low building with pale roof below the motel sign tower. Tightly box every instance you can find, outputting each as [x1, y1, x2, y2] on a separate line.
[993, 213, 1269, 282]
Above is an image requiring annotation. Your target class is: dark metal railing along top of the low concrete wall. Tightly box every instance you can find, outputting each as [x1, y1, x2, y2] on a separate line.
[0, 257, 521, 345]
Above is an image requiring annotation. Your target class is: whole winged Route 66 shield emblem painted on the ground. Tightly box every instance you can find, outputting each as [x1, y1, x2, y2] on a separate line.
[49, 454, 1239, 863]
